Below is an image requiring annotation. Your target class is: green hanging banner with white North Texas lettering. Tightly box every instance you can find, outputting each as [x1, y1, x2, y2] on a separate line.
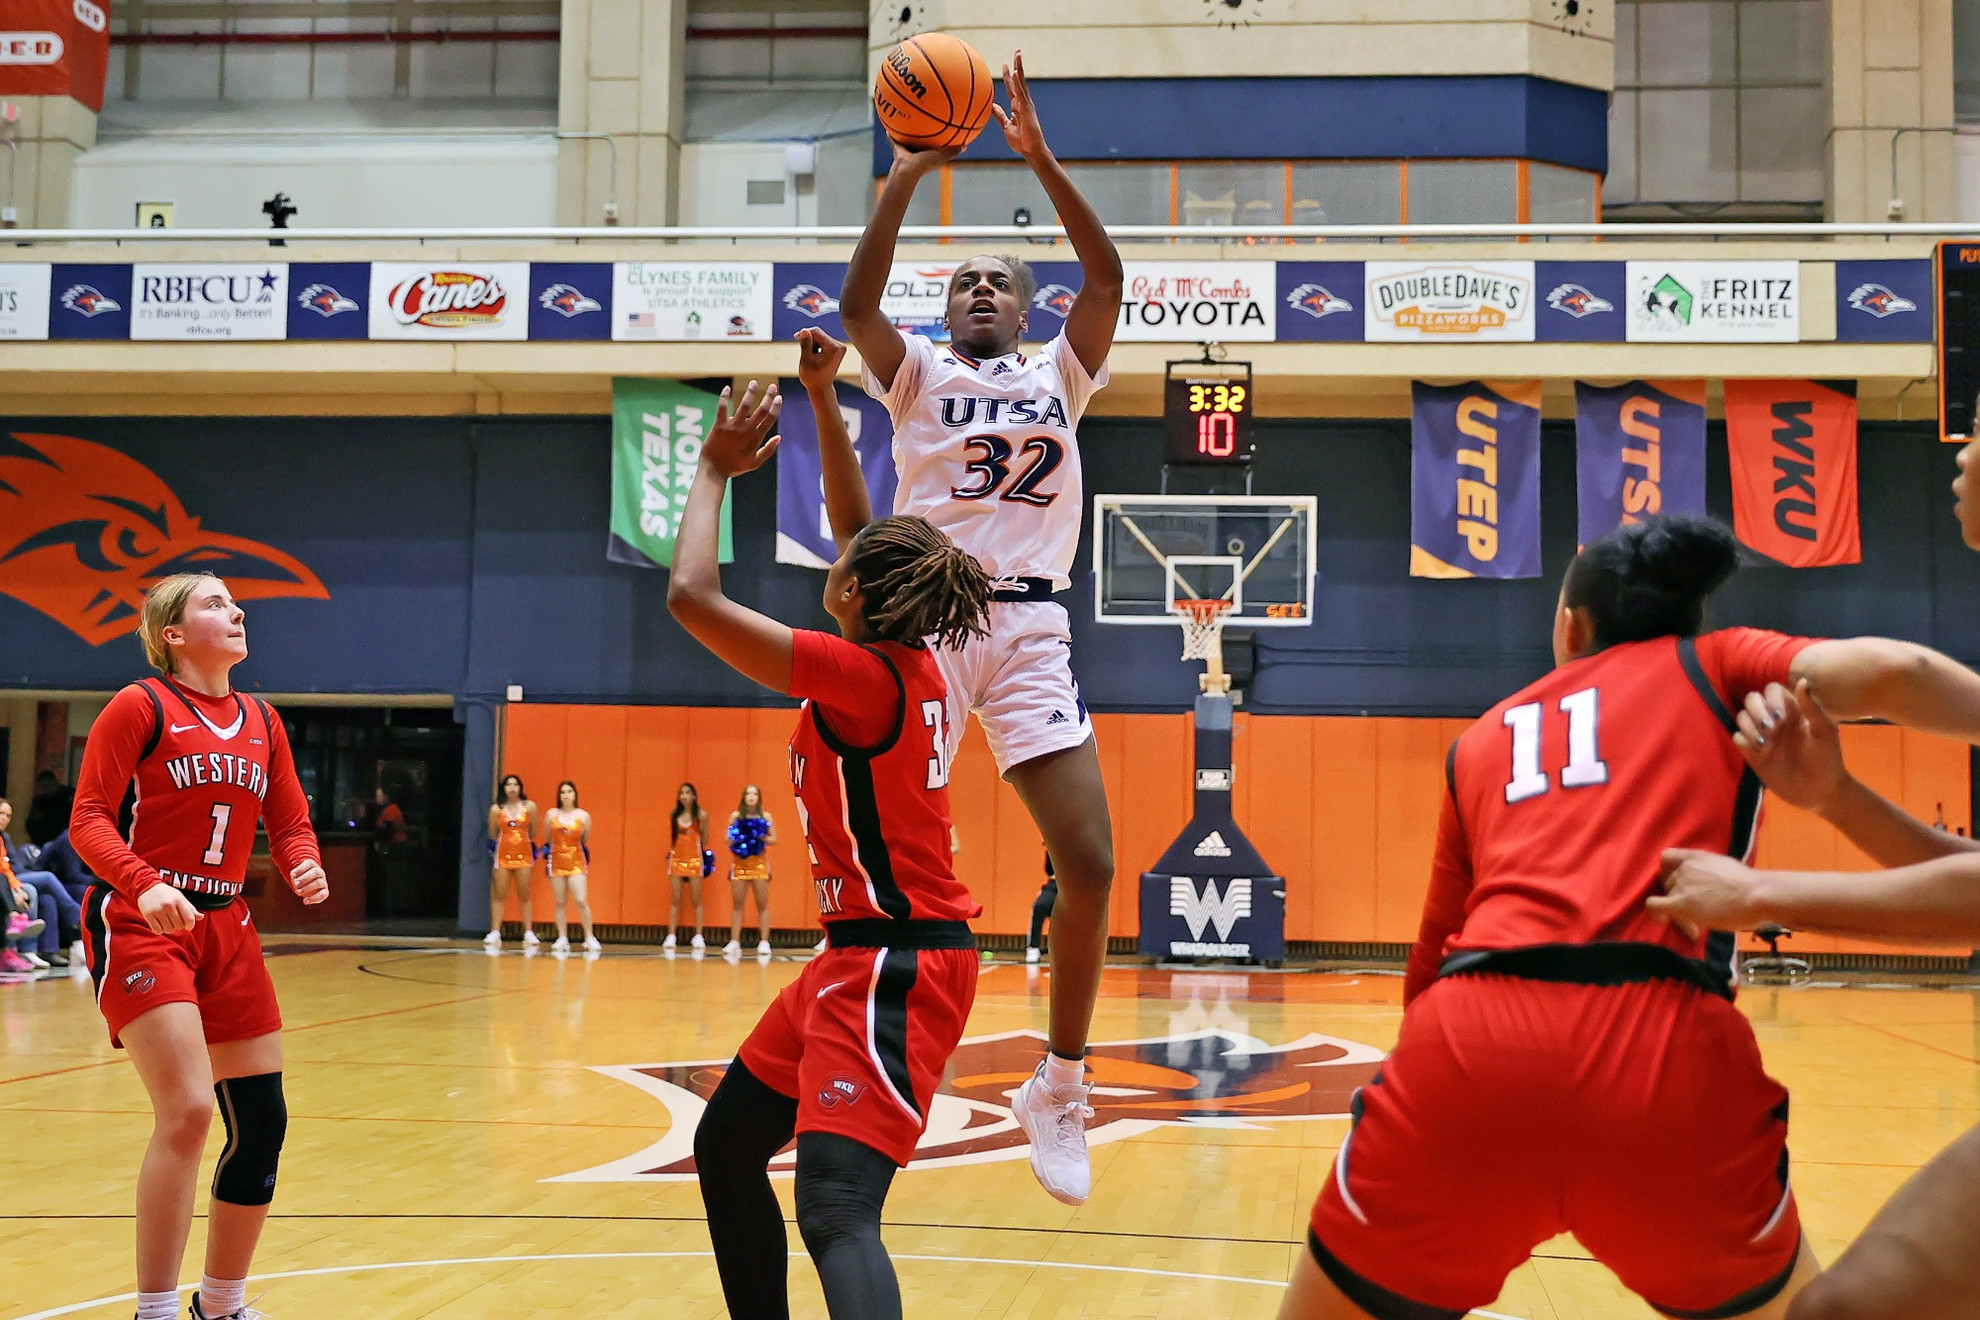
[606, 376, 735, 568]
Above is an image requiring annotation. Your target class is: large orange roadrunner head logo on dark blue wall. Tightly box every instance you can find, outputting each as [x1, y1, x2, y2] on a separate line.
[0, 431, 331, 645]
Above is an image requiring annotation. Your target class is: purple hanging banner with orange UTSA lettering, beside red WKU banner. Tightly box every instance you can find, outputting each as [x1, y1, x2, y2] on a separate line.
[1574, 380, 1705, 546]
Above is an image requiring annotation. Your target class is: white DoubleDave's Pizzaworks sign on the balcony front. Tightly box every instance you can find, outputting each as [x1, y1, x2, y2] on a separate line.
[1364, 261, 1533, 344]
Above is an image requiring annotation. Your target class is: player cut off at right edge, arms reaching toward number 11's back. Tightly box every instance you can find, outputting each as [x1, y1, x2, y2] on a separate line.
[1649, 443, 1980, 1320]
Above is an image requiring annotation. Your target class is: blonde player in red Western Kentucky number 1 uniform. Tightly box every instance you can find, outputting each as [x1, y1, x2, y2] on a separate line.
[69, 574, 329, 1320]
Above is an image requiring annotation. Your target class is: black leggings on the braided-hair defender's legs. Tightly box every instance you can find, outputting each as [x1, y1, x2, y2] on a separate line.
[695, 1059, 901, 1320]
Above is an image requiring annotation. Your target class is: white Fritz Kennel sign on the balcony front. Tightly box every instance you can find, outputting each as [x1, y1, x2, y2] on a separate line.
[1628, 261, 1802, 344]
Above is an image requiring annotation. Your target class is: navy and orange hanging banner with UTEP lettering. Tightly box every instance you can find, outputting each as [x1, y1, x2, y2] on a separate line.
[1410, 380, 1540, 578]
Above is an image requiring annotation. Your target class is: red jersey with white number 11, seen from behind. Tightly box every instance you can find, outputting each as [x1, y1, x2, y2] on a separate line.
[1404, 627, 1810, 999]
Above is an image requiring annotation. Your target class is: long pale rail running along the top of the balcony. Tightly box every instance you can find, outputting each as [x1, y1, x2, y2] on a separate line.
[0, 222, 1980, 245]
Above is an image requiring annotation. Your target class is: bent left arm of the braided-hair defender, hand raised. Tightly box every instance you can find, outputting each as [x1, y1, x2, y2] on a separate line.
[667, 380, 792, 696]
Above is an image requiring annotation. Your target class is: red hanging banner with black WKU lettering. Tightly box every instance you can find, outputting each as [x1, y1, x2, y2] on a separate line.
[1727, 380, 1863, 568]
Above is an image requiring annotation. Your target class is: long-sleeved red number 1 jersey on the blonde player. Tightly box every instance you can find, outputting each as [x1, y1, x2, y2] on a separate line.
[69, 679, 319, 908]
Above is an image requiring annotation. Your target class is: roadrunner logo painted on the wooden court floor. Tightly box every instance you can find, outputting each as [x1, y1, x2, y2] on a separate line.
[546, 1029, 1382, 1183]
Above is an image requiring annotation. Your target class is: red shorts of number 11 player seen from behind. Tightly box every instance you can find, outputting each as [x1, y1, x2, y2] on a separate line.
[1309, 974, 1802, 1320]
